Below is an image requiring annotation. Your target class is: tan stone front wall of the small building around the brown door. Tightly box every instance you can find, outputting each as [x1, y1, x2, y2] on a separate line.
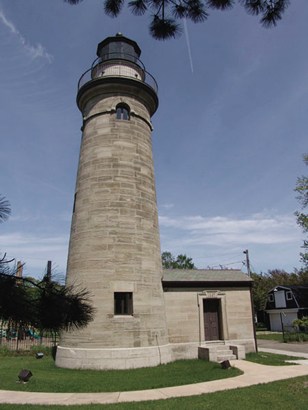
[164, 287, 255, 357]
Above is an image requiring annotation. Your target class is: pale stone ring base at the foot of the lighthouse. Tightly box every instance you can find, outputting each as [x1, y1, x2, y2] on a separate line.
[56, 344, 172, 370]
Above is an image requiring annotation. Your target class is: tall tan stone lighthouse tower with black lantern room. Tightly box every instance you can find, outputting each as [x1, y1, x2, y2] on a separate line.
[56, 33, 171, 369]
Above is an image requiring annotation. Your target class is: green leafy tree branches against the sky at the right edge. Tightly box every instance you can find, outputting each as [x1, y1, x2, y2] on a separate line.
[295, 154, 308, 271]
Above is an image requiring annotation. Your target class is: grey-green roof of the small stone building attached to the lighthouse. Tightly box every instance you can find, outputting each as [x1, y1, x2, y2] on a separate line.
[162, 269, 252, 287]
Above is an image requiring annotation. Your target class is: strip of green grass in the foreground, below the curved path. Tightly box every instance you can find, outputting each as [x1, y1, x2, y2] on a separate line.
[0, 376, 308, 410]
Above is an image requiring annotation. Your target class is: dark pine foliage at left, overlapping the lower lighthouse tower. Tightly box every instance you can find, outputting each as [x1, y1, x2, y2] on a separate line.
[0, 265, 94, 333]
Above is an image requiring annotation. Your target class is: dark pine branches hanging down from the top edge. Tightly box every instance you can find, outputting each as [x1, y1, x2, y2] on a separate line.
[64, 0, 290, 40]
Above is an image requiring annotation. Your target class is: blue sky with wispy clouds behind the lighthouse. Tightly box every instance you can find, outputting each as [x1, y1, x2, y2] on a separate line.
[0, 0, 308, 276]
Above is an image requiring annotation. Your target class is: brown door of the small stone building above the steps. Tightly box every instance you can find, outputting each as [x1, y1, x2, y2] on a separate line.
[203, 299, 220, 340]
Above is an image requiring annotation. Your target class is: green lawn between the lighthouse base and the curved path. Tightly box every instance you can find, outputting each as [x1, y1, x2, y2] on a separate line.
[0, 355, 242, 393]
